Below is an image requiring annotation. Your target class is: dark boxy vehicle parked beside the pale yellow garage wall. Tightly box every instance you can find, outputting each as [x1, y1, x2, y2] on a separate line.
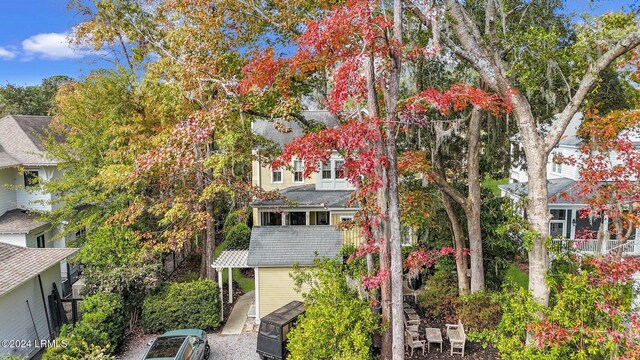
[256, 301, 304, 360]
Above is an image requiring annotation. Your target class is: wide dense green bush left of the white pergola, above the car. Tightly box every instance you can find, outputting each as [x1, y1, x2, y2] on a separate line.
[142, 280, 220, 333]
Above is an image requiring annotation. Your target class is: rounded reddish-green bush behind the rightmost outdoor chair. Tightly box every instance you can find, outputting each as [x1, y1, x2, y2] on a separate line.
[457, 292, 502, 331]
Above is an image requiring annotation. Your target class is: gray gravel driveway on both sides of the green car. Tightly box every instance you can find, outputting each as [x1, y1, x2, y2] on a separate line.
[120, 332, 259, 360]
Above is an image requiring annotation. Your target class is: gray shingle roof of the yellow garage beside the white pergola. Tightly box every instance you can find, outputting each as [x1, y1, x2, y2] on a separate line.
[247, 226, 342, 267]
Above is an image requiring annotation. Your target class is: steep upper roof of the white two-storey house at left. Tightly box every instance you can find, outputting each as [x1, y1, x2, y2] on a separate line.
[0, 115, 57, 167]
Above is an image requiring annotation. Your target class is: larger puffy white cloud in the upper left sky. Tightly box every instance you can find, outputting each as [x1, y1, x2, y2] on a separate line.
[22, 33, 89, 61]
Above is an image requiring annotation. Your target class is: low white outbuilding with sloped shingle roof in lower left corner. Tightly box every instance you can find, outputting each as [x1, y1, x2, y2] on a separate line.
[0, 243, 77, 358]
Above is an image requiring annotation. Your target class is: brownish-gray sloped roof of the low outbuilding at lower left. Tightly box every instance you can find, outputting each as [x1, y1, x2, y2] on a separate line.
[0, 243, 78, 296]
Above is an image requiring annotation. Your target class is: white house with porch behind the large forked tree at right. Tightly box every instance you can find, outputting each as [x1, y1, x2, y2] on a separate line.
[500, 115, 640, 255]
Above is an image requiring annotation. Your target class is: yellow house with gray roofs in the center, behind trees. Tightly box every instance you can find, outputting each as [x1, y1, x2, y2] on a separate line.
[247, 111, 361, 321]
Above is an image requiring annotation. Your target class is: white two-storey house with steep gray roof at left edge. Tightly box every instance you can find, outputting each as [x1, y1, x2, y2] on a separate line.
[0, 115, 78, 289]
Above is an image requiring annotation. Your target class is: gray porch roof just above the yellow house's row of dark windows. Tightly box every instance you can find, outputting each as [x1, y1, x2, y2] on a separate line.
[251, 184, 356, 208]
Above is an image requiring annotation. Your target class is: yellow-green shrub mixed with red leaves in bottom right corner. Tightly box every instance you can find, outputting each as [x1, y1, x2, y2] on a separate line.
[480, 256, 640, 359]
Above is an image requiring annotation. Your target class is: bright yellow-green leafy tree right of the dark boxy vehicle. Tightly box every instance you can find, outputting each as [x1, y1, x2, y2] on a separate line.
[287, 259, 380, 359]
